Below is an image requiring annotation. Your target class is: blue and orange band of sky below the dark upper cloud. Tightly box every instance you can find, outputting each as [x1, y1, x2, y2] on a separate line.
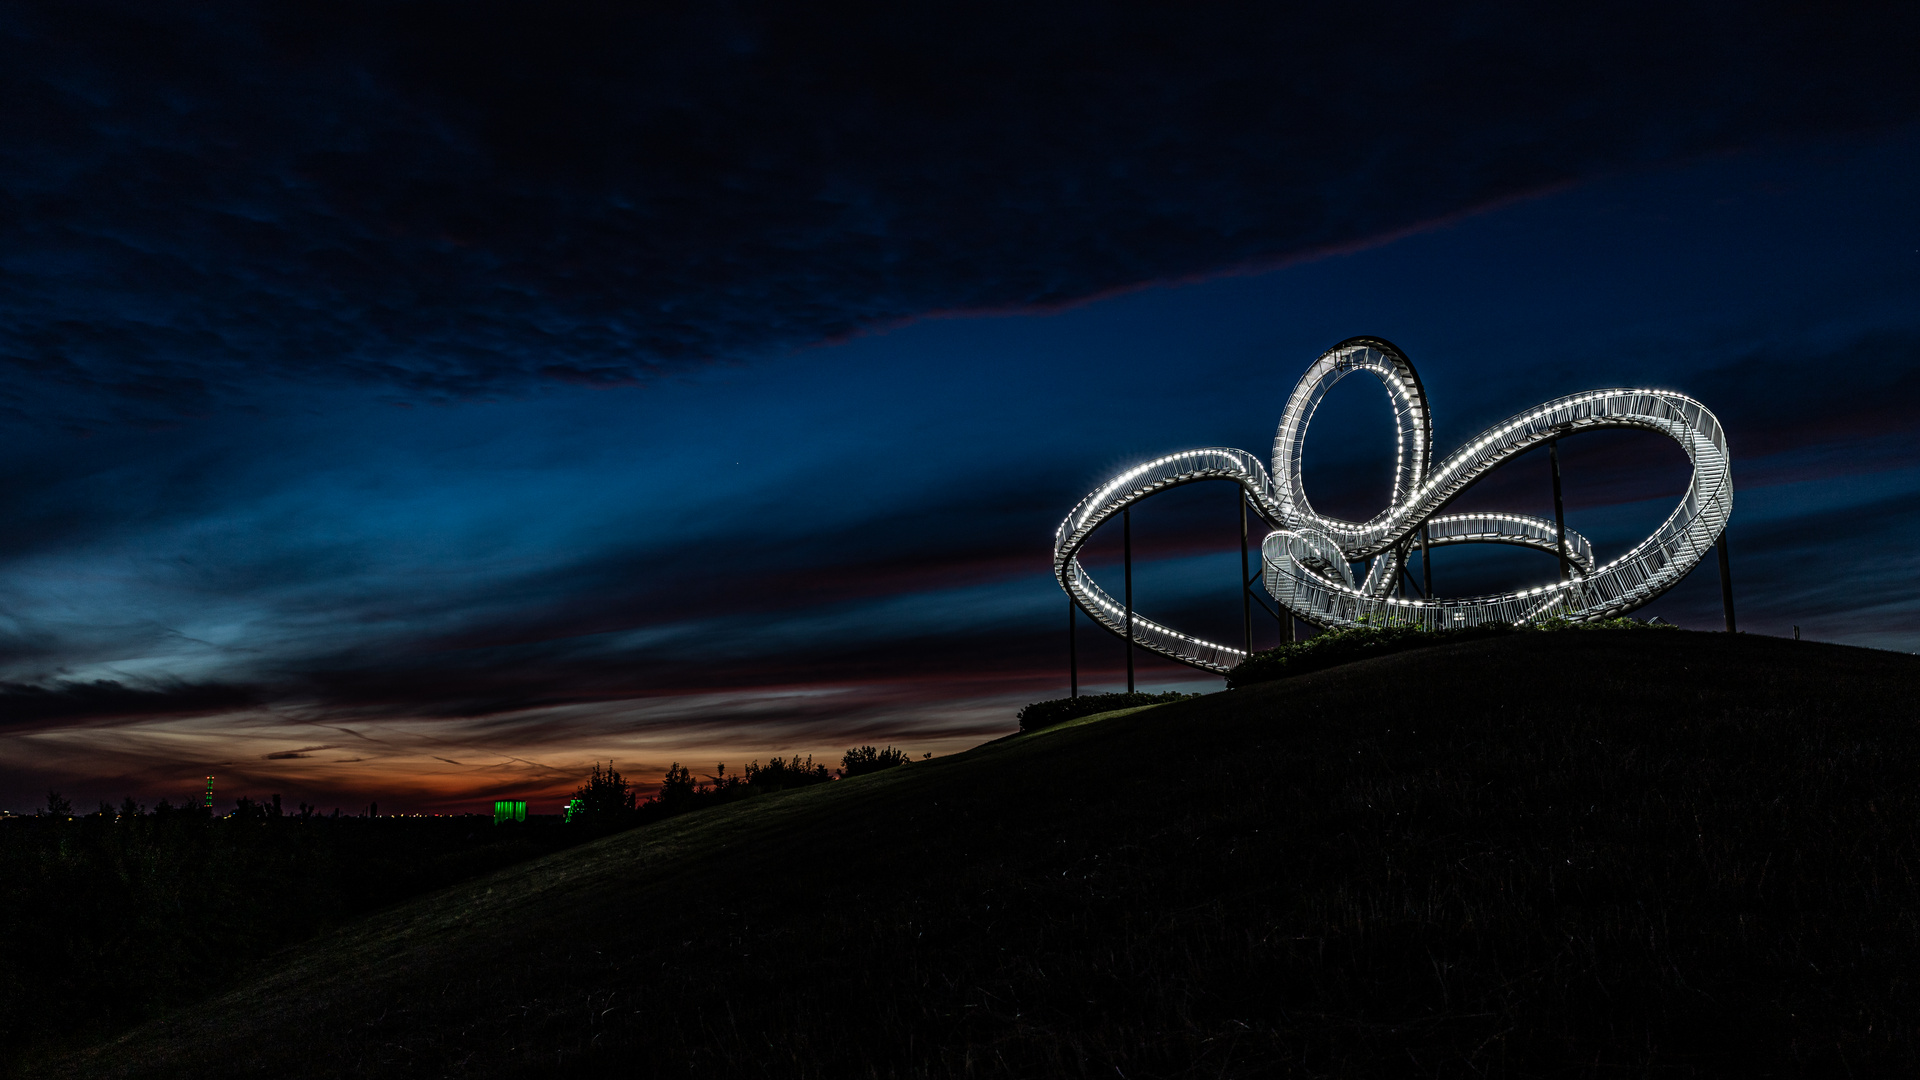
[0, 125, 1920, 805]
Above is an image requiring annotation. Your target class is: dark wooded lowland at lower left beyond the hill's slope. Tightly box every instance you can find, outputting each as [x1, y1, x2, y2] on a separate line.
[0, 799, 595, 1076]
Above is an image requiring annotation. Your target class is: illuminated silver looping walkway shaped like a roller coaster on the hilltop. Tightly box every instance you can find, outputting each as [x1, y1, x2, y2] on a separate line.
[1054, 338, 1734, 673]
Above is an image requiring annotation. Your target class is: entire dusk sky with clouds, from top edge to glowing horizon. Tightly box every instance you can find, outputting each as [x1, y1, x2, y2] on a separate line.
[0, 0, 1920, 813]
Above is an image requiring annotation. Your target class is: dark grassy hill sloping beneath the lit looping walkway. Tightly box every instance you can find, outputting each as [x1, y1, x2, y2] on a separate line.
[42, 632, 1920, 1078]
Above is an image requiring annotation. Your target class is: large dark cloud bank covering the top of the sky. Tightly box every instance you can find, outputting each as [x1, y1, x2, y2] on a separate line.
[0, 0, 1920, 421]
